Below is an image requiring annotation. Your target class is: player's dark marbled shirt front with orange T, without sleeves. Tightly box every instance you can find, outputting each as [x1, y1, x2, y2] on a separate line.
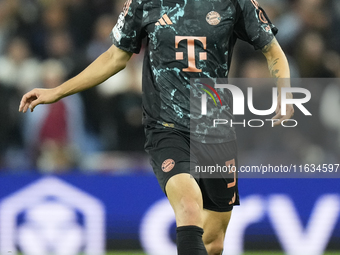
[139, 0, 236, 141]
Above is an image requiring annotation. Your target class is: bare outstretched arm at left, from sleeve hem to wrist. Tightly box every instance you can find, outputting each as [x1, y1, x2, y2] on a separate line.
[55, 45, 131, 99]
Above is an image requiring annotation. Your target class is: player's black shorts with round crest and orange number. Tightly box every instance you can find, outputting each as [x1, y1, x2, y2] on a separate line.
[145, 127, 240, 212]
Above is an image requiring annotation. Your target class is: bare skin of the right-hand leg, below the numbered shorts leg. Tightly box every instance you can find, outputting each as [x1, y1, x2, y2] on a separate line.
[203, 209, 231, 255]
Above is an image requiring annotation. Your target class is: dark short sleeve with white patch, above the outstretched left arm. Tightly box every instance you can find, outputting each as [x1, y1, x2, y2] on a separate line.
[110, 0, 145, 53]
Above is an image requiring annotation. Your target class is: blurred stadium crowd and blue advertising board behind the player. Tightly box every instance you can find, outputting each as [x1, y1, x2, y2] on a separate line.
[0, 0, 340, 255]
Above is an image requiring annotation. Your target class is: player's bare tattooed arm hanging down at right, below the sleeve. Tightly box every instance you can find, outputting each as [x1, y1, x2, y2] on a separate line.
[262, 37, 294, 126]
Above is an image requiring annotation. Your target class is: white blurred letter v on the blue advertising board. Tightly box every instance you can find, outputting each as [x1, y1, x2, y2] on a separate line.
[268, 194, 340, 255]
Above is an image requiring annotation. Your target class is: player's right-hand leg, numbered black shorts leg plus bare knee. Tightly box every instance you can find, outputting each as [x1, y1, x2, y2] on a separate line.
[195, 141, 239, 255]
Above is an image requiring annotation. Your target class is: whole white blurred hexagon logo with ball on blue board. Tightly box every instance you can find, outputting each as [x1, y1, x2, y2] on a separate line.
[0, 177, 105, 255]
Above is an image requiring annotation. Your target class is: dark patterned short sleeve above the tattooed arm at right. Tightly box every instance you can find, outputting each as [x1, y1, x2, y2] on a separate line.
[234, 0, 278, 49]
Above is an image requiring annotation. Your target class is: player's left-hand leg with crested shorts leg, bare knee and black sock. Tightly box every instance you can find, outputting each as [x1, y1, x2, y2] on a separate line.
[145, 129, 208, 255]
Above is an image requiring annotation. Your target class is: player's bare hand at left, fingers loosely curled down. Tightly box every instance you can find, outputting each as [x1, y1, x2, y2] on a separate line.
[19, 88, 60, 112]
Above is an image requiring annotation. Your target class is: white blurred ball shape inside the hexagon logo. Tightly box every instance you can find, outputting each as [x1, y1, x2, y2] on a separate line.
[18, 201, 84, 255]
